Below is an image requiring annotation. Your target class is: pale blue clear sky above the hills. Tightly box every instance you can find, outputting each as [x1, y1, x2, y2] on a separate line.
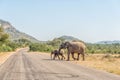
[0, 0, 120, 42]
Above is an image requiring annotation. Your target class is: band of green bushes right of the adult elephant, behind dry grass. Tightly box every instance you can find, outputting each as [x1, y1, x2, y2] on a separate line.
[86, 43, 120, 54]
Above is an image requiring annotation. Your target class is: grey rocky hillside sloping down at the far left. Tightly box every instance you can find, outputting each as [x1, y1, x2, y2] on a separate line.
[0, 20, 40, 42]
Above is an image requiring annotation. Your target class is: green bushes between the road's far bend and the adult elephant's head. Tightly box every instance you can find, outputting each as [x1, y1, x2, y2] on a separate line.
[30, 38, 64, 52]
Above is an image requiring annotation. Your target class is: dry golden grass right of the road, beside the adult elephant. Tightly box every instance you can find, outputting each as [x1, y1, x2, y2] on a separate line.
[75, 54, 120, 75]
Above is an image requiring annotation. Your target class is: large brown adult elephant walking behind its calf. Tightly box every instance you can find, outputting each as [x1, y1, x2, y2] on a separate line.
[59, 41, 86, 61]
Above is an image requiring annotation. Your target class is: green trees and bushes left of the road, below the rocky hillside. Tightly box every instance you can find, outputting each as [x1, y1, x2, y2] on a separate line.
[0, 26, 30, 52]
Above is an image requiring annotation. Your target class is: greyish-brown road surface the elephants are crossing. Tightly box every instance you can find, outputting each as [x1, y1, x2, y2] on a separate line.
[0, 49, 120, 80]
